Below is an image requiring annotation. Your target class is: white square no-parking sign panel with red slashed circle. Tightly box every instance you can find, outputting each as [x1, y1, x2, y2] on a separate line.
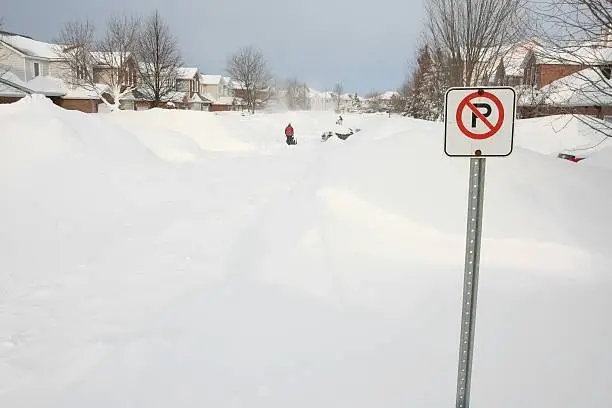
[444, 87, 516, 157]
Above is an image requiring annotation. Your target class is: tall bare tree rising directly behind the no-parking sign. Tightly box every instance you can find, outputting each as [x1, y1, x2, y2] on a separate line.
[426, 0, 527, 86]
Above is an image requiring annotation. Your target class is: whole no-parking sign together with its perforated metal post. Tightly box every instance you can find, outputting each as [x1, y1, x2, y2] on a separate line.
[444, 87, 516, 408]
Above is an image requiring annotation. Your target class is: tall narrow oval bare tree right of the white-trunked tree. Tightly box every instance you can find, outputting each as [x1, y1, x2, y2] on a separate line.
[137, 11, 181, 106]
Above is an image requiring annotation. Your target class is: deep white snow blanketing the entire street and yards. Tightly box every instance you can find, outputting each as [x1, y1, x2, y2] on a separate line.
[0, 97, 612, 408]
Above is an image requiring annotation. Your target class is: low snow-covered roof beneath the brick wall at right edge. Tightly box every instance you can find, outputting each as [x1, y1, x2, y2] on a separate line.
[541, 68, 612, 106]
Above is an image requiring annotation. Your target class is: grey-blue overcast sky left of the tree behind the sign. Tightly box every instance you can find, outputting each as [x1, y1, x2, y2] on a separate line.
[0, 0, 424, 94]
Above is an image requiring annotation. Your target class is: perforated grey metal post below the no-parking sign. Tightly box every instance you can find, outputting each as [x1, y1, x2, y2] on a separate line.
[456, 158, 486, 408]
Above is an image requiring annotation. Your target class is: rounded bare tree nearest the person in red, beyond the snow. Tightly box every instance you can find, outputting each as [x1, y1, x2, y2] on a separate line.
[226, 45, 272, 113]
